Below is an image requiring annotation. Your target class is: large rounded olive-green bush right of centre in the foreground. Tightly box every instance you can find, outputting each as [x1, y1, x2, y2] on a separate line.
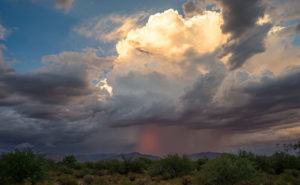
[202, 154, 256, 185]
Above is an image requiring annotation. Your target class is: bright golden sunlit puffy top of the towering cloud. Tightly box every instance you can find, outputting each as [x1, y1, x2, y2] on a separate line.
[116, 9, 227, 59]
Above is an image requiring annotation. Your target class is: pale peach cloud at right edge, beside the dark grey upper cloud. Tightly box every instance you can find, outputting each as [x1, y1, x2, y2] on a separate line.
[242, 21, 300, 74]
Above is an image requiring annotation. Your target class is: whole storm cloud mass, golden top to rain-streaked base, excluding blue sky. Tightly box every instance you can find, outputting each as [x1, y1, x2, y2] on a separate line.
[0, 0, 300, 154]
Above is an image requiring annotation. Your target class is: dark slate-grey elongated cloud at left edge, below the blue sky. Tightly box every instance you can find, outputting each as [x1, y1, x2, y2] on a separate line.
[0, 73, 90, 104]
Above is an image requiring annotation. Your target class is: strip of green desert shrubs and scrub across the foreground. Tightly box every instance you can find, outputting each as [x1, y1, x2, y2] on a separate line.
[0, 145, 300, 185]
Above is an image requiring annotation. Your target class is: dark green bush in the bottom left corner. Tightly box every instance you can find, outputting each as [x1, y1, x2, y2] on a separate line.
[0, 149, 47, 184]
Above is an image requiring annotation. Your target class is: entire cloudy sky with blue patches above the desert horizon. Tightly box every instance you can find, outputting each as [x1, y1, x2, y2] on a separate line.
[0, 0, 300, 155]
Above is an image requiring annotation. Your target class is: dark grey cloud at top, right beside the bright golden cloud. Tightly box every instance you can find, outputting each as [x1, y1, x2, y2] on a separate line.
[218, 0, 272, 70]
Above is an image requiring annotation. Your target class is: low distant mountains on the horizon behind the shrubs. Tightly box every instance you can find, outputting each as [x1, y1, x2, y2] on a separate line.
[46, 152, 221, 162]
